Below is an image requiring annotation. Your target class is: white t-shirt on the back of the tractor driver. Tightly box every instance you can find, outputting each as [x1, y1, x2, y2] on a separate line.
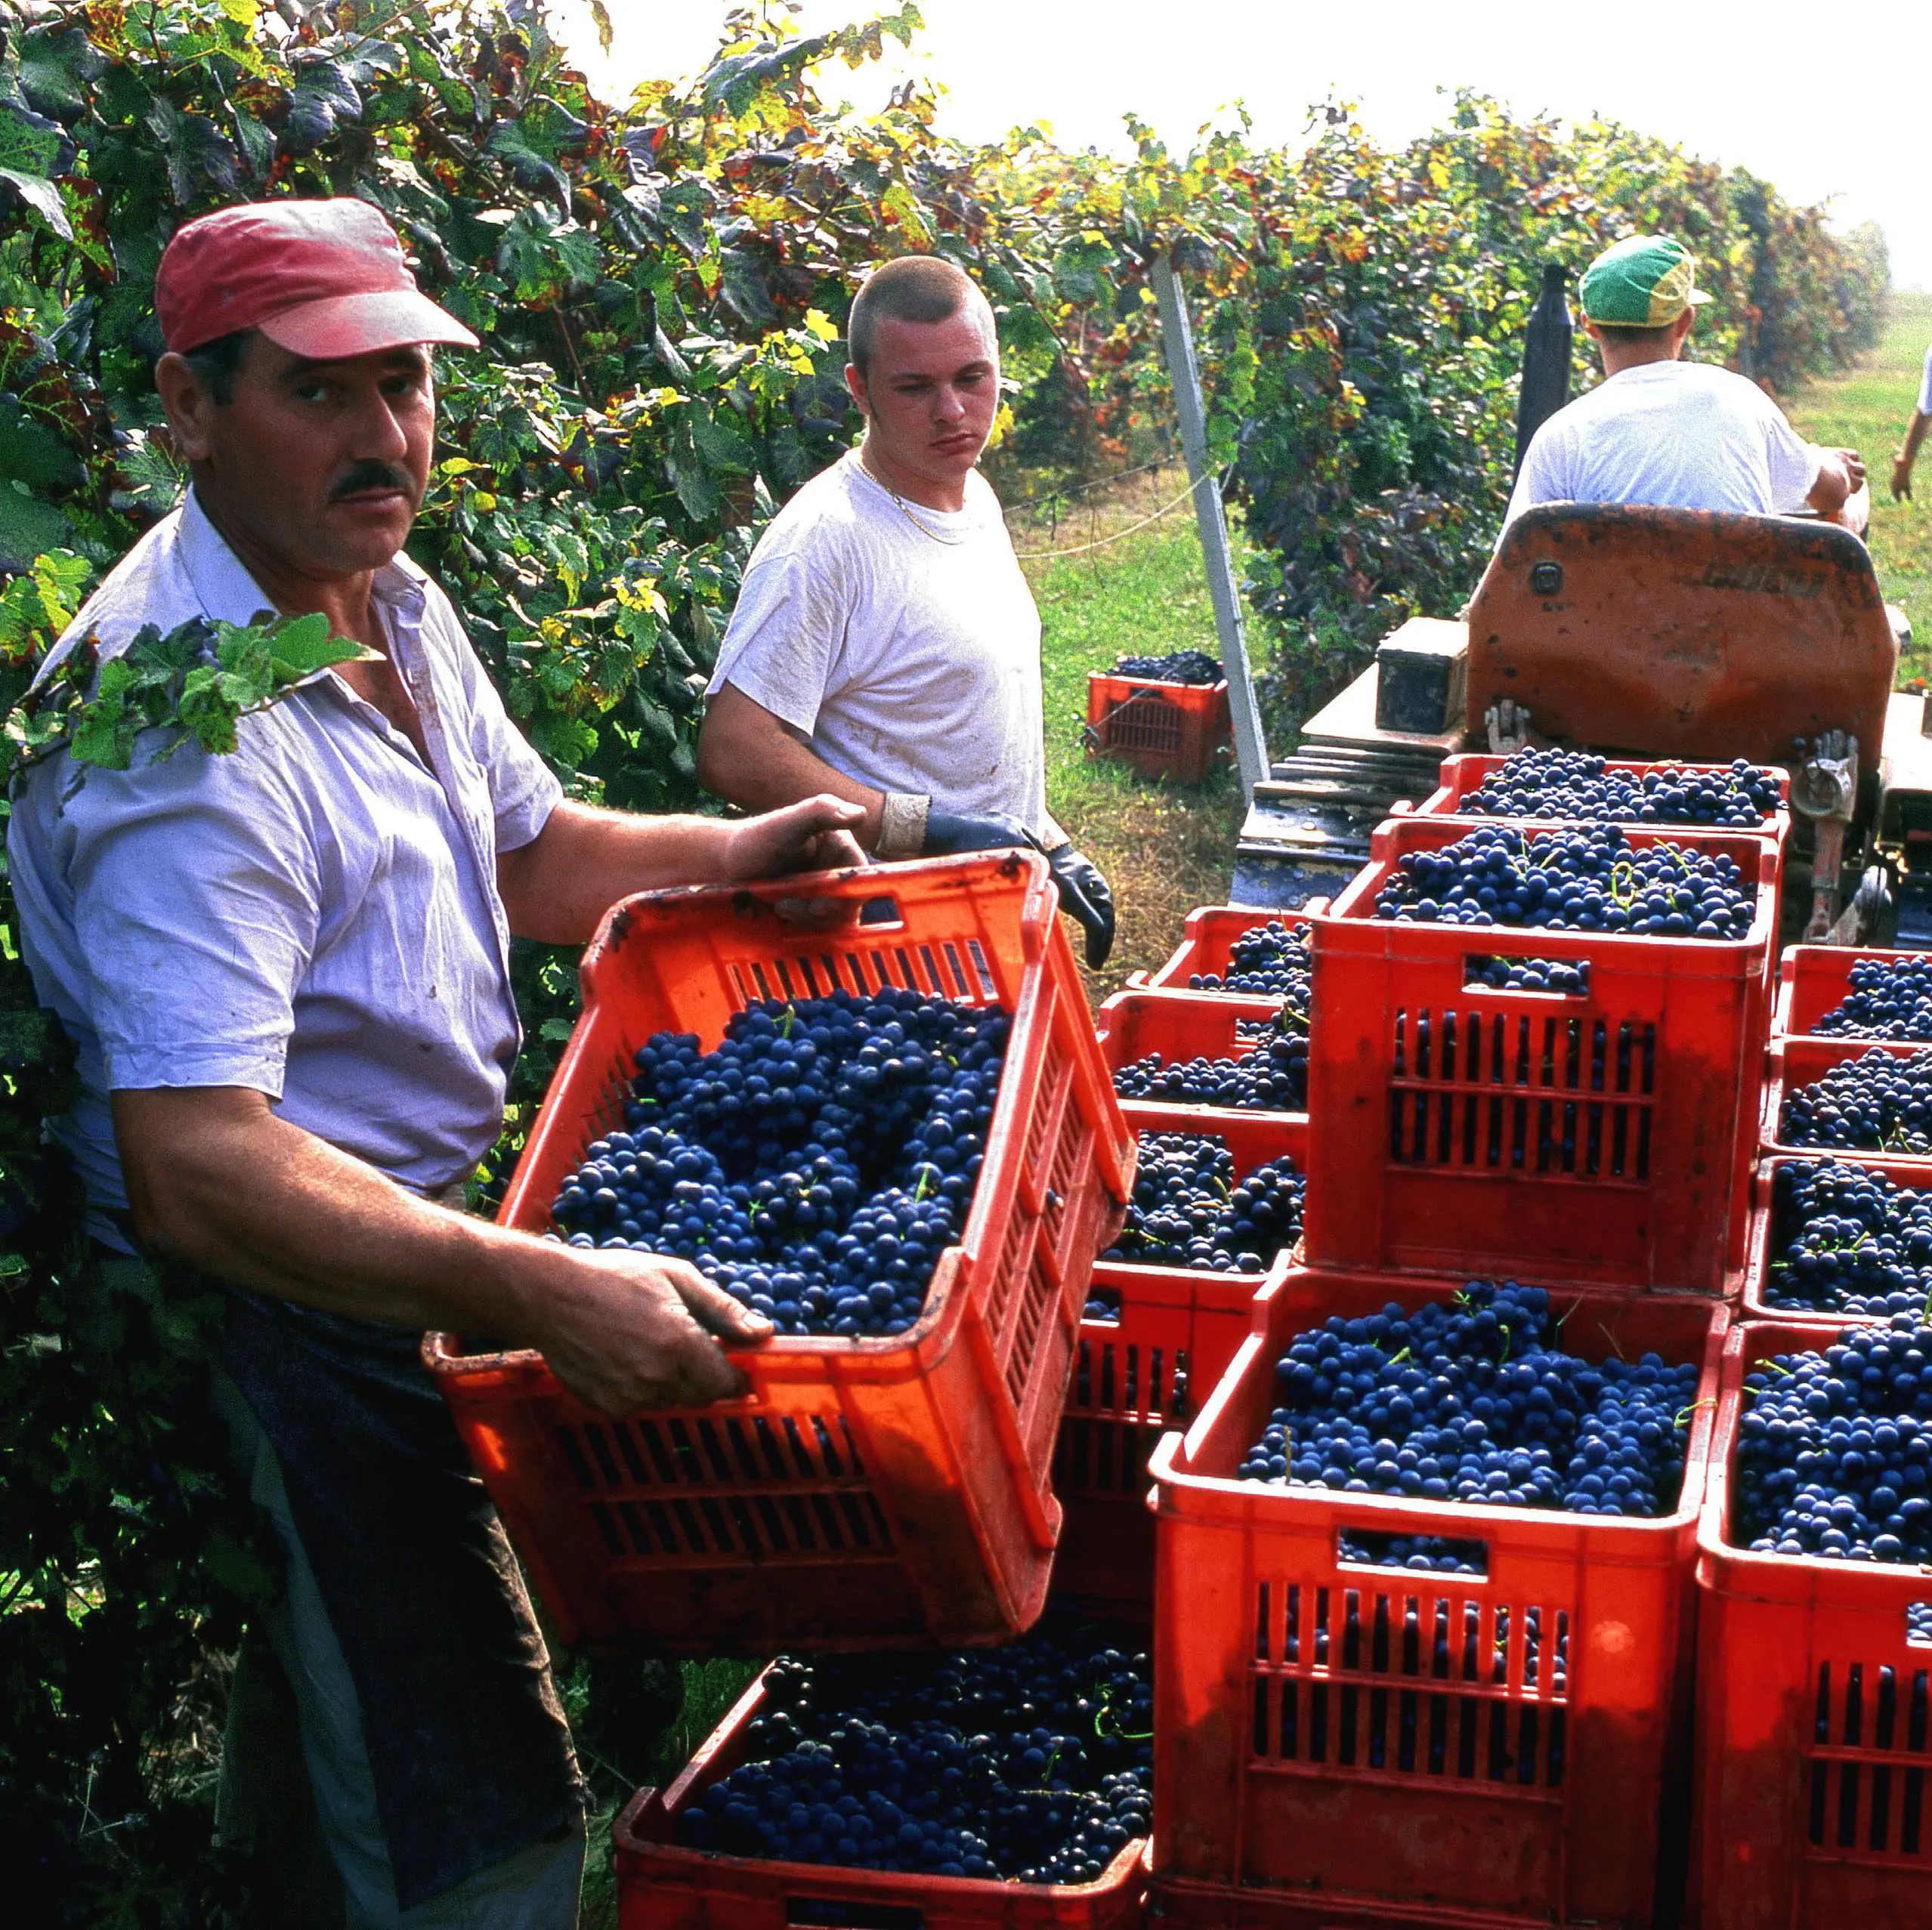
[1503, 361, 1820, 530]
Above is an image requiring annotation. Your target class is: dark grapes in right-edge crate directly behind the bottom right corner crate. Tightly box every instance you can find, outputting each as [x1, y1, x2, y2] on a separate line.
[1764, 1160, 1932, 1317]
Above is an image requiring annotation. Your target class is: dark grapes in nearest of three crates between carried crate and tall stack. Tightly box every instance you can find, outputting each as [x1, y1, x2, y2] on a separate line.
[1101, 1132, 1306, 1273]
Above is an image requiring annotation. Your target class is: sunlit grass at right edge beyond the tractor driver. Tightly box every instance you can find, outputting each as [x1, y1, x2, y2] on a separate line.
[1789, 292, 1932, 676]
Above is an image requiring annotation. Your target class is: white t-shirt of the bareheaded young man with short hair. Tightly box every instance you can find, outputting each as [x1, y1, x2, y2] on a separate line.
[711, 450, 1062, 845]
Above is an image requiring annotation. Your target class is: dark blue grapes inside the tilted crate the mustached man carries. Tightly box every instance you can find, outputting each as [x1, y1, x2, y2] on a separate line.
[552, 987, 1010, 1335]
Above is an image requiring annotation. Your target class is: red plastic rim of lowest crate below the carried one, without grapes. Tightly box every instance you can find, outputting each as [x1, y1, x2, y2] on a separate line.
[611, 1675, 1148, 1930]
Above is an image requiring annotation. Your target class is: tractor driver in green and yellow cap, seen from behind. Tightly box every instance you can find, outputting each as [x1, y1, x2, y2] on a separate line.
[1505, 233, 1865, 527]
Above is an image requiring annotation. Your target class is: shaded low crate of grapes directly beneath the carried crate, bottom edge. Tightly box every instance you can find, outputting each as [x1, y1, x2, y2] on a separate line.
[614, 1601, 1154, 1930]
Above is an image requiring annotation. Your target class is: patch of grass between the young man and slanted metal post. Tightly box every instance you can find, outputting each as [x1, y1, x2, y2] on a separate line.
[1014, 468, 1242, 1002]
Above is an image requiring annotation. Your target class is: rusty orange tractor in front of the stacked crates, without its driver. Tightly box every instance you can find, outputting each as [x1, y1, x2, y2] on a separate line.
[1232, 502, 1932, 945]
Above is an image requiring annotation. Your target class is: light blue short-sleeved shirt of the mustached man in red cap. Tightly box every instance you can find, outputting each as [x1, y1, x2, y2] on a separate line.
[8, 493, 561, 1237]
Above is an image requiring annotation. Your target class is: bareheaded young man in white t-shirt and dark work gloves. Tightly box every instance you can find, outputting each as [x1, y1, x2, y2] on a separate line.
[697, 255, 1113, 966]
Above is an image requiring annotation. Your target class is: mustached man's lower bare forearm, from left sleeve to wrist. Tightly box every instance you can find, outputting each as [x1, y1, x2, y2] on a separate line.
[114, 1088, 561, 1343]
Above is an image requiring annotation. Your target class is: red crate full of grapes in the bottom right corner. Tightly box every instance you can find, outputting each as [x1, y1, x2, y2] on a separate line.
[1692, 1312, 1932, 1930]
